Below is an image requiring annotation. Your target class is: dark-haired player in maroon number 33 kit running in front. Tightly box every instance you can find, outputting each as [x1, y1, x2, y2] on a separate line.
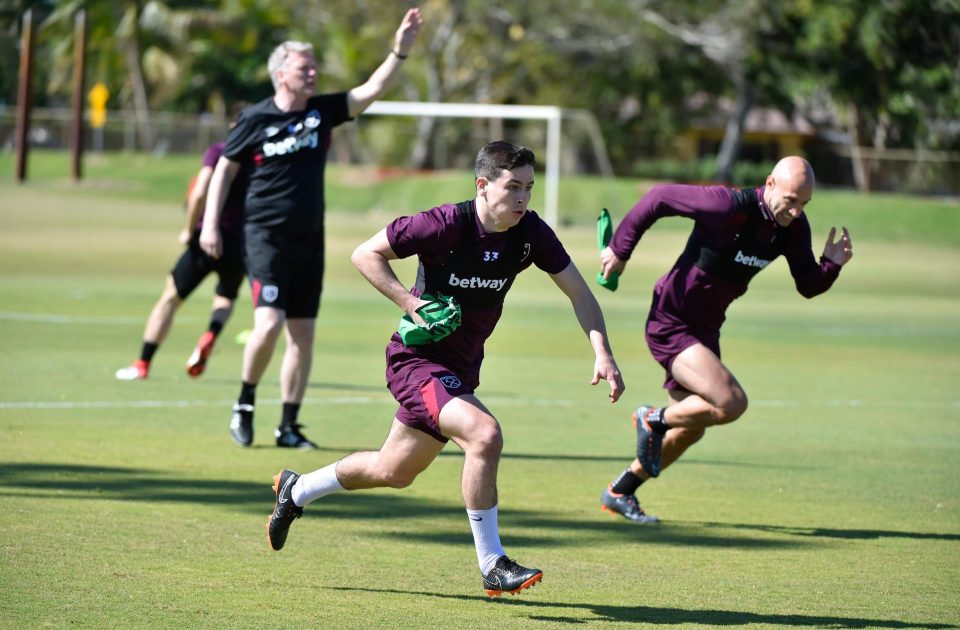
[268, 141, 623, 596]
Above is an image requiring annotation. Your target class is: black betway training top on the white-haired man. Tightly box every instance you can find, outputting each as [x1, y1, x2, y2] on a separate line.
[223, 92, 350, 234]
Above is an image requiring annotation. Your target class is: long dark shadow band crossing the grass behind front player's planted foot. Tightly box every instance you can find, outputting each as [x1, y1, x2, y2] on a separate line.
[0, 462, 960, 550]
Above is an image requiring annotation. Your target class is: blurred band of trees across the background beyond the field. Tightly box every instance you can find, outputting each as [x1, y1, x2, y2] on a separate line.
[0, 0, 960, 188]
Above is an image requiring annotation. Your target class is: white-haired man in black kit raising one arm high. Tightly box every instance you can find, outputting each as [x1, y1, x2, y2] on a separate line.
[200, 9, 422, 448]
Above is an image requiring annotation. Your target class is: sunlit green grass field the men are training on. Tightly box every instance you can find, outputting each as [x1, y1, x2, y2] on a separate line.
[0, 154, 960, 628]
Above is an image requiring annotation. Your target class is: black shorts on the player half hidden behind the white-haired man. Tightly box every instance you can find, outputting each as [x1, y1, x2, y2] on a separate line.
[170, 230, 244, 300]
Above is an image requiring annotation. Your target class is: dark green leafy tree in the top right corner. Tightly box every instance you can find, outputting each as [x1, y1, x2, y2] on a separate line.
[796, 0, 960, 190]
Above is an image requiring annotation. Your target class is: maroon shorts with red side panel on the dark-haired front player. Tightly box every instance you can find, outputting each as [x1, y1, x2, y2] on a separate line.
[387, 341, 477, 443]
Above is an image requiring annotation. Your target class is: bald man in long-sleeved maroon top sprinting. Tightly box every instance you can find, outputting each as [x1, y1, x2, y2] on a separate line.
[600, 156, 853, 523]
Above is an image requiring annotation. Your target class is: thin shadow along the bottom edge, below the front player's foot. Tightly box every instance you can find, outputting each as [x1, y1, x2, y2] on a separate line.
[323, 586, 957, 630]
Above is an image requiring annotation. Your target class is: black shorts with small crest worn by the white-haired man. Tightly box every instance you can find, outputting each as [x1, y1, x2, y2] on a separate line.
[244, 223, 323, 319]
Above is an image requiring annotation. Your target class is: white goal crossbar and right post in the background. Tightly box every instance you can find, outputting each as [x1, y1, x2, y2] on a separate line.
[363, 101, 568, 227]
